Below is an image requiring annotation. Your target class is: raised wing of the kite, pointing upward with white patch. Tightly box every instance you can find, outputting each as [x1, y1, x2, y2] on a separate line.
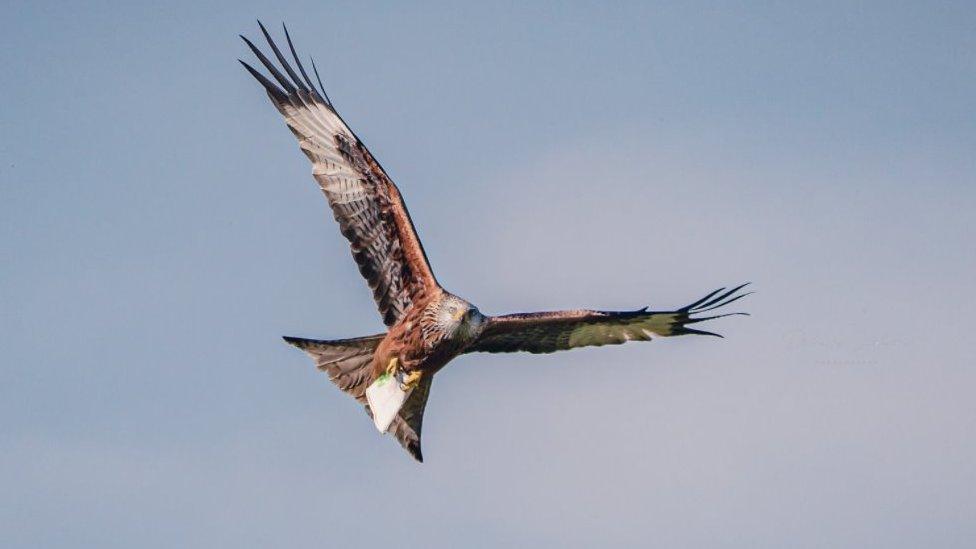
[241, 22, 438, 326]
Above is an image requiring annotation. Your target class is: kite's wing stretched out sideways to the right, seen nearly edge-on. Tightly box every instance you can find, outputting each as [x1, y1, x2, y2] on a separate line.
[465, 284, 748, 353]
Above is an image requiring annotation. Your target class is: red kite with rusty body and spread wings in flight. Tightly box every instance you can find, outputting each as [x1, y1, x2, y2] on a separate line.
[239, 21, 748, 461]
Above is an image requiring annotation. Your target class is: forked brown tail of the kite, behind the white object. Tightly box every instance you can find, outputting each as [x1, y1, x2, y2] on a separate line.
[284, 334, 433, 462]
